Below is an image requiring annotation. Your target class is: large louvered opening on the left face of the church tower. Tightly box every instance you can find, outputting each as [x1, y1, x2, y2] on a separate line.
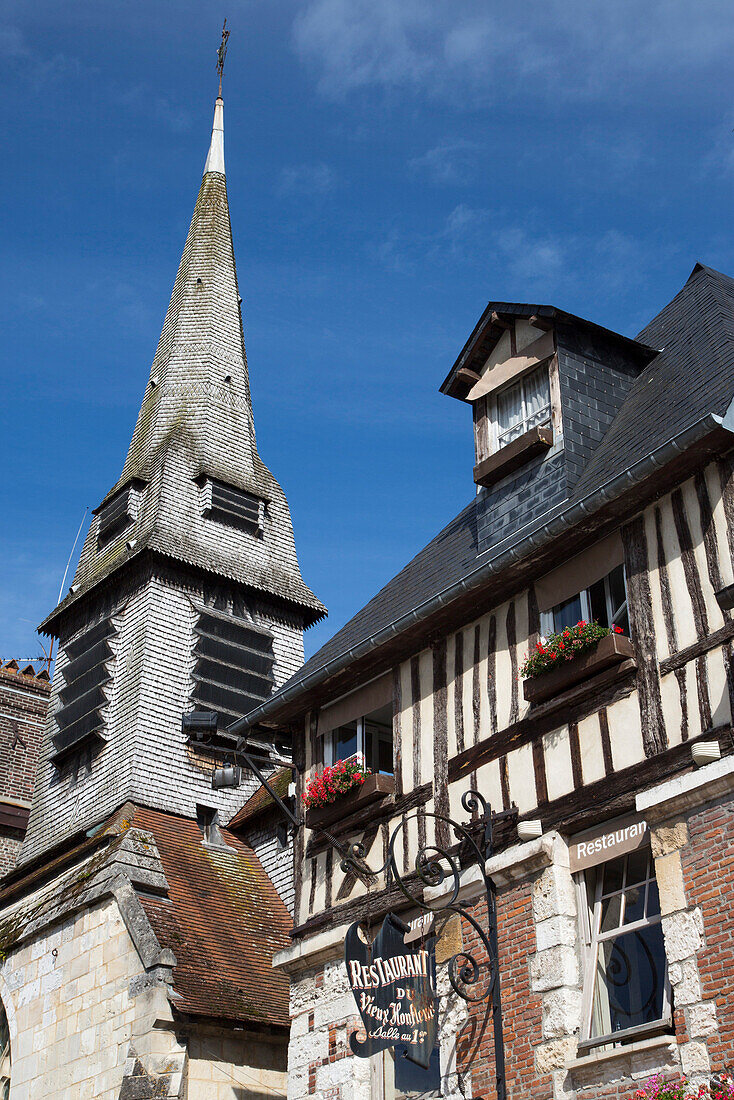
[52, 619, 117, 763]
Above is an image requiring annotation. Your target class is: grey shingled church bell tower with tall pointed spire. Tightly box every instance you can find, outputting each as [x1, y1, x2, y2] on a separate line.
[21, 83, 326, 862]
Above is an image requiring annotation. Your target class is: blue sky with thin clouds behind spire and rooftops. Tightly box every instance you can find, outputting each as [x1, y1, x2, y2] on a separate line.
[0, 0, 734, 658]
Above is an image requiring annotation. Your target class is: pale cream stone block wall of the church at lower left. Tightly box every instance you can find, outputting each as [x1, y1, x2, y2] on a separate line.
[0, 899, 184, 1100]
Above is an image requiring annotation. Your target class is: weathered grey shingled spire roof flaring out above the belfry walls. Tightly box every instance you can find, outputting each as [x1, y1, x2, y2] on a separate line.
[42, 103, 326, 630]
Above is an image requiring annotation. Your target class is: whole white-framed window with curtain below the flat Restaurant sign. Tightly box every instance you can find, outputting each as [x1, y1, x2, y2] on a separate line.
[579, 846, 670, 1048]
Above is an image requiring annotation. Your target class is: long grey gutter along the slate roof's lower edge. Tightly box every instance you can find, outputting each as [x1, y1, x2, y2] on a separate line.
[229, 403, 734, 734]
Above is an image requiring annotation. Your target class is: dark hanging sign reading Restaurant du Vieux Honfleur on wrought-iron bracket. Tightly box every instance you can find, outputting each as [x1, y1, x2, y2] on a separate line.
[344, 913, 438, 1068]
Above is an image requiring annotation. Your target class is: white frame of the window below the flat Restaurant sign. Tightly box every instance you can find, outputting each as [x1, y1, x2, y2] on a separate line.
[573, 845, 672, 1054]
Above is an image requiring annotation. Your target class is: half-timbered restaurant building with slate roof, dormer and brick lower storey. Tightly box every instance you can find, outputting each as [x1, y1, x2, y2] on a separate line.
[244, 264, 734, 1100]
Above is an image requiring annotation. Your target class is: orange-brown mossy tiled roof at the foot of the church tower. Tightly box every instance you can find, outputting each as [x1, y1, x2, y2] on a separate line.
[132, 806, 292, 1027]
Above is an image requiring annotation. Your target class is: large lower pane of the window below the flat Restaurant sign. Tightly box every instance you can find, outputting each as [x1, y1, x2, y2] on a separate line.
[592, 924, 666, 1037]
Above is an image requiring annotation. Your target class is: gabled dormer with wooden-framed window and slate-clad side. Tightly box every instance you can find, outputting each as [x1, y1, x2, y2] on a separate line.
[441, 303, 654, 490]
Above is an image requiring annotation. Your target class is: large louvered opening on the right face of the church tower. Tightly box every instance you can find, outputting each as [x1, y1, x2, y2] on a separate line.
[193, 607, 275, 729]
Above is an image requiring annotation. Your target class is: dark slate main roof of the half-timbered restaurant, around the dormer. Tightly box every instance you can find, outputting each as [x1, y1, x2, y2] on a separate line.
[248, 264, 734, 722]
